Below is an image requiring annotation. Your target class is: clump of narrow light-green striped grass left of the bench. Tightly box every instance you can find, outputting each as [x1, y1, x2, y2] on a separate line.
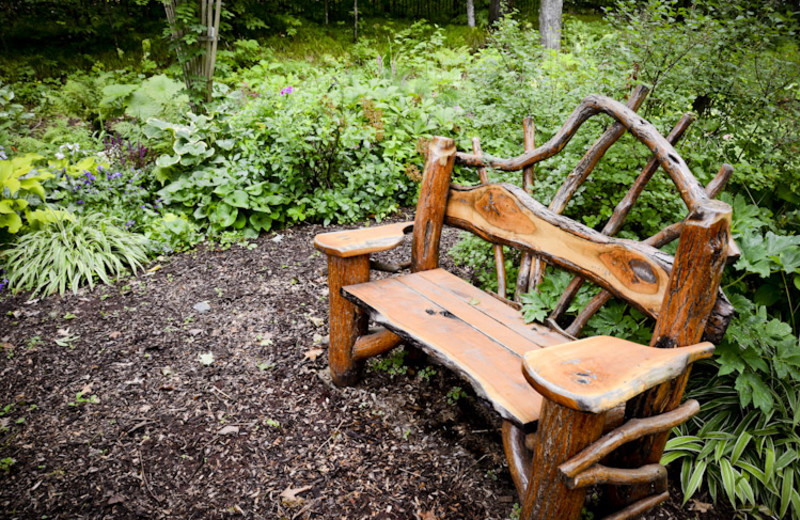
[5, 209, 147, 295]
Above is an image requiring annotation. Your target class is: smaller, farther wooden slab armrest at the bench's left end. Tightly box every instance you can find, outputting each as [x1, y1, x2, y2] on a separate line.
[314, 222, 414, 258]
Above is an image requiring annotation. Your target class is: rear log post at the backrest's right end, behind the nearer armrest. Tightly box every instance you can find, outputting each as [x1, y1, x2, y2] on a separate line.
[608, 200, 731, 510]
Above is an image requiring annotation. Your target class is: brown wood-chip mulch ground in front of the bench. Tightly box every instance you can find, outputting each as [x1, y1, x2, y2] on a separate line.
[0, 212, 730, 520]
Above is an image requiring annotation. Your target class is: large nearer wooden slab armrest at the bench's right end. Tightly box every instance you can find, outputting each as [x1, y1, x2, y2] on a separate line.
[522, 336, 714, 414]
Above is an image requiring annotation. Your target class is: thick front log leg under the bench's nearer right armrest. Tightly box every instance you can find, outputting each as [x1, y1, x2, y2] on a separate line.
[519, 399, 605, 520]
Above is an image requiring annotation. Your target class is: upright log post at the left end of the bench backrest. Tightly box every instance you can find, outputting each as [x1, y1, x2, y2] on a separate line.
[411, 136, 456, 272]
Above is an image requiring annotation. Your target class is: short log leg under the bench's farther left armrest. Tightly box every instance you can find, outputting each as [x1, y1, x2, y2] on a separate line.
[328, 255, 369, 386]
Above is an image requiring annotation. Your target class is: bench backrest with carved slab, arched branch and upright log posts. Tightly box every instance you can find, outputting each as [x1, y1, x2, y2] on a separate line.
[412, 88, 738, 346]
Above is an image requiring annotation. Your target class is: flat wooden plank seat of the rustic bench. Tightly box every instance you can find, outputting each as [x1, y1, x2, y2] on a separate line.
[342, 269, 572, 431]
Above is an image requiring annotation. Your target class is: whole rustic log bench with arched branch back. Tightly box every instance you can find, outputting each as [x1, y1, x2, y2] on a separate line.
[315, 87, 737, 520]
